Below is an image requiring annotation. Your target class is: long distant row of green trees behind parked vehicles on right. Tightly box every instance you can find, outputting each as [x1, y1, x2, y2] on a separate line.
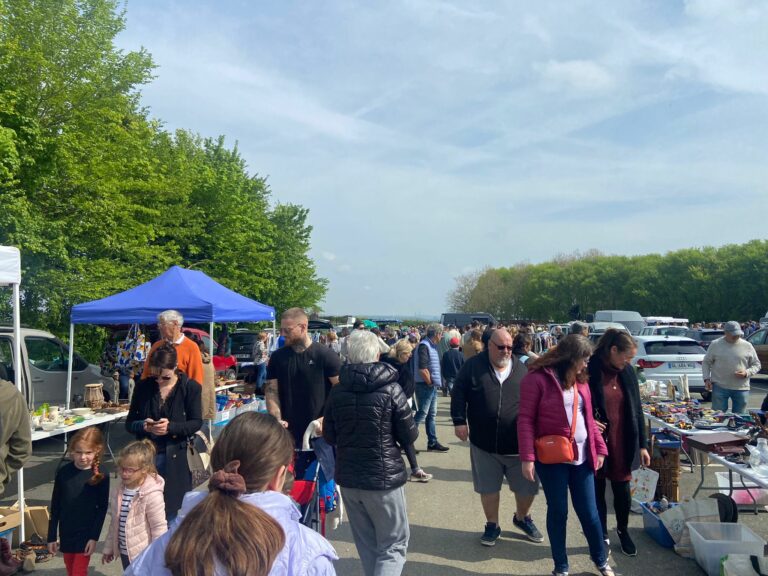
[454, 240, 768, 321]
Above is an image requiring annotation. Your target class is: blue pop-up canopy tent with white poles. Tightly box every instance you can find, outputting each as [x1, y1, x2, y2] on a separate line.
[67, 266, 275, 407]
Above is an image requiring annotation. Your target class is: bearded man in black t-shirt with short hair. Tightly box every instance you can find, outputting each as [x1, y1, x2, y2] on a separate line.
[264, 308, 341, 448]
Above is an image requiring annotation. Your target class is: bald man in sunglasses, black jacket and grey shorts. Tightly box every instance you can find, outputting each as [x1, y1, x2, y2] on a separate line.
[451, 329, 544, 546]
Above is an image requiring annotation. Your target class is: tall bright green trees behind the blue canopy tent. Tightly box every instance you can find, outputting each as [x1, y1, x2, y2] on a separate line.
[0, 0, 326, 348]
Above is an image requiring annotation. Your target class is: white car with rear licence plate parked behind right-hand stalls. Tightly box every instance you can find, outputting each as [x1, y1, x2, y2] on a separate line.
[632, 336, 712, 401]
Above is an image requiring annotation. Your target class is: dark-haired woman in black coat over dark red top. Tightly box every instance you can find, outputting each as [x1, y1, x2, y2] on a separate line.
[588, 328, 651, 556]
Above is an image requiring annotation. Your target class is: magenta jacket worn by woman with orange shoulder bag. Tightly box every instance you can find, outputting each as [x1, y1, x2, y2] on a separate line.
[517, 368, 608, 470]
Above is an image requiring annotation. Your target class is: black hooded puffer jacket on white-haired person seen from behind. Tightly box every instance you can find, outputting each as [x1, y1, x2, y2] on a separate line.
[323, 362, 419, 490]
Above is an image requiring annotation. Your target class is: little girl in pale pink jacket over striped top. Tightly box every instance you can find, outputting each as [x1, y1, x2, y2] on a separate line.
[102, 440, 168, 570]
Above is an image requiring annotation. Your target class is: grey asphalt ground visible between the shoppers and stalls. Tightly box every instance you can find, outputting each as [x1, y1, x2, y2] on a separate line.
[0, 377, 768, 576]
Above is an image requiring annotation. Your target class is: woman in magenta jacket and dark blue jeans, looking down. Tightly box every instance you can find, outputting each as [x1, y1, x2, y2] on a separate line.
[517, 334, 614, 576]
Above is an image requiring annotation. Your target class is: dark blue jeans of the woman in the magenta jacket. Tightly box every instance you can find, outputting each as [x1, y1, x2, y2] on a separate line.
[536, 462, 608, 572]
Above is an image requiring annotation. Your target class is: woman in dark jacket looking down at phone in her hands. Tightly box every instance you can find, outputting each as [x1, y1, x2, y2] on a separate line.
[125, 343, 203, 521]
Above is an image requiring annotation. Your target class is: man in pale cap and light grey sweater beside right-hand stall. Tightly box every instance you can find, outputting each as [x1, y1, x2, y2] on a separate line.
[702, 320, 760, 414]
